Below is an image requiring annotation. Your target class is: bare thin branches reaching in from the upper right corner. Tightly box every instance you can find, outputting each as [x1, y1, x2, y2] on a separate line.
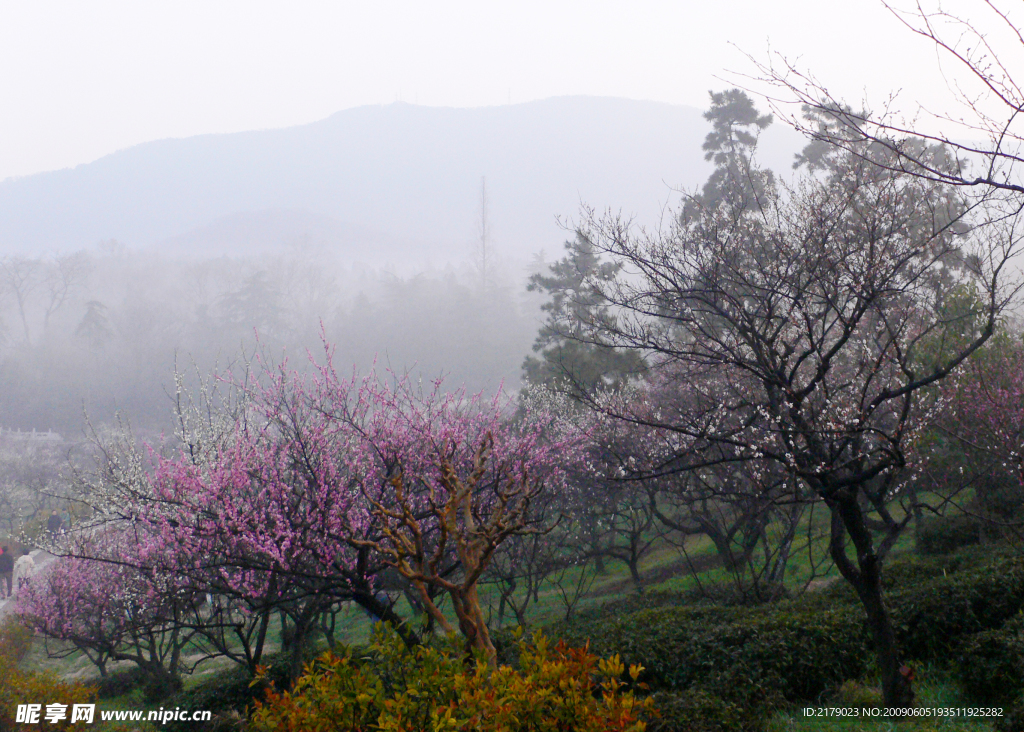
[751, 0, 1024, 197]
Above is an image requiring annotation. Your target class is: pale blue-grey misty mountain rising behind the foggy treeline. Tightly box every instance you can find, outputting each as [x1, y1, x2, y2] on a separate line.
[0, 96, 801, 262]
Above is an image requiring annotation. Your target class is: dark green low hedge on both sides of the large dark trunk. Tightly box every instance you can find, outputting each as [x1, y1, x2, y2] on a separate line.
[551, 555, 1024, 730]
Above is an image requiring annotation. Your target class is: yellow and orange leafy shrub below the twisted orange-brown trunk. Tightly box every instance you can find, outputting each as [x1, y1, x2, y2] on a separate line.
[253, 631, 650, 732]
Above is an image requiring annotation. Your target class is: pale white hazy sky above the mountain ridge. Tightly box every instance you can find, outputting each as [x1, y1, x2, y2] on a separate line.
[0, 0, 1007, 180]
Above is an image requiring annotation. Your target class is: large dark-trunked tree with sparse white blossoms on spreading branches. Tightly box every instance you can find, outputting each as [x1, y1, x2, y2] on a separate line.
[564, 133, 1021, 706]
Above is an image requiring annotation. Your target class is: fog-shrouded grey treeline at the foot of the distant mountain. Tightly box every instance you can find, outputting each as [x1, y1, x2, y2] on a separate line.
[0, 241, 543, 438]
